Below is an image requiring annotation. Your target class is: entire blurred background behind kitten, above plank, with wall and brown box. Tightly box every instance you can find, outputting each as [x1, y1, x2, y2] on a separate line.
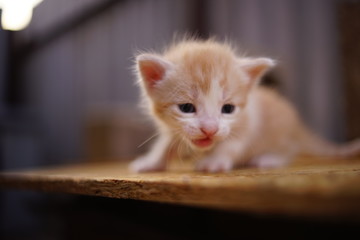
[0, 0, 360, 238]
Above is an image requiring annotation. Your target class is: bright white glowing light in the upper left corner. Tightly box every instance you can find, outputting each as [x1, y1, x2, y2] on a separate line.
[0, 0, 43, 31]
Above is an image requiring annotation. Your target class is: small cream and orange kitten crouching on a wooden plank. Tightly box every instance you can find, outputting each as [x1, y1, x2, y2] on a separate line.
[130, 40, 360, 172]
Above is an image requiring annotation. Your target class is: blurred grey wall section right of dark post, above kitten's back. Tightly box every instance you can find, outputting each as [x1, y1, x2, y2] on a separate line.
[209, 0, 344, 141]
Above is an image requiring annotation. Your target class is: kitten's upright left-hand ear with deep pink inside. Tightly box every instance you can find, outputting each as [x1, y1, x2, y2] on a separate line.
[136, 54, 173, 89]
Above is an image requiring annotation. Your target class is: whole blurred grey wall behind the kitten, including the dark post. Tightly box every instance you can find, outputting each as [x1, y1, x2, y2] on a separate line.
[0, 0, 344, 169]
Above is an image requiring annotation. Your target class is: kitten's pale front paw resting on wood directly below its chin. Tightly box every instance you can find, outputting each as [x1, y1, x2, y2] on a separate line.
[196, 157, 234, 172]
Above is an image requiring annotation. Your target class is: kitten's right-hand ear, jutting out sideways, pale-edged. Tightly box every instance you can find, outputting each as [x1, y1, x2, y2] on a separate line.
[240, 58, 276, 85]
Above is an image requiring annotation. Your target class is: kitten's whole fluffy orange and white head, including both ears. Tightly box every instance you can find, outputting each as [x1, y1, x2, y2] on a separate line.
[136, 41, 274, 149]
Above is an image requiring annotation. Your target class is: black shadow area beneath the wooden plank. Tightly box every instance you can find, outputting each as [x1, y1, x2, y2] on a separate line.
[0, 194, 360, 239]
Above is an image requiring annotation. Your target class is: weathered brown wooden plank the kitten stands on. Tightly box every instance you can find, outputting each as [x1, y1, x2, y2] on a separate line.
[0, 159, 360, 219]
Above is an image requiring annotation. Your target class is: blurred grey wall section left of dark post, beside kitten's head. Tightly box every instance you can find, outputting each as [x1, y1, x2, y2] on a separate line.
[9, 0, 189, 163]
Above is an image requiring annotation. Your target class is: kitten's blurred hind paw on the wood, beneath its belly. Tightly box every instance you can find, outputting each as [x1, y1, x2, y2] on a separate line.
[249, 153, 291, 169]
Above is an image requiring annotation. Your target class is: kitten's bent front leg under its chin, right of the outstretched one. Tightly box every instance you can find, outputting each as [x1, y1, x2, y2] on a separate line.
[196, 142, 245, 172]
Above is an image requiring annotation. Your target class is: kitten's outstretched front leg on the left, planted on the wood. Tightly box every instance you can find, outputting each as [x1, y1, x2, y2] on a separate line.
[130, 135, 171, 172]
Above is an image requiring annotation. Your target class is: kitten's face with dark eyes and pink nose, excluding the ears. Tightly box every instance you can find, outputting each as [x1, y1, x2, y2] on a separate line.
[151, 61, 247, 149]
